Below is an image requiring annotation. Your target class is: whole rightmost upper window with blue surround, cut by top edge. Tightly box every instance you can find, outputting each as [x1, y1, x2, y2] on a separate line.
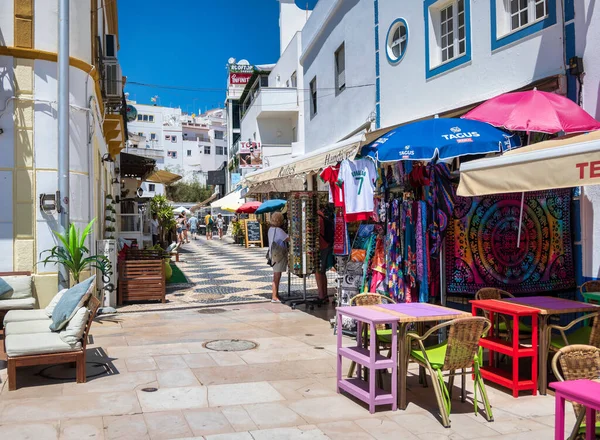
[491, 0, 556, 50]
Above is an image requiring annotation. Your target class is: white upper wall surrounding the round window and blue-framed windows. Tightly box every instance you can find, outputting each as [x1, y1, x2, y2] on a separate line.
[379, 0, 564, 127]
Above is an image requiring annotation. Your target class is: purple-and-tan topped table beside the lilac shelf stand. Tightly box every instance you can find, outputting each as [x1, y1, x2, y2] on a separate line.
[337, 303, 471, 409]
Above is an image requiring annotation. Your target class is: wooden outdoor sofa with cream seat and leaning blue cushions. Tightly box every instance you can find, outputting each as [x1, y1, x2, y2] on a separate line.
[4, 277, 100, 391]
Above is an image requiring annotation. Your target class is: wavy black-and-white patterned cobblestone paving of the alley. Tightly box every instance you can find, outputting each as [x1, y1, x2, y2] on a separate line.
[118, 237, 335, 312]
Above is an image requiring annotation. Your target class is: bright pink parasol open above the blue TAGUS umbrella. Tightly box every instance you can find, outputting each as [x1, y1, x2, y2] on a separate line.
[463, 90, 600, 134]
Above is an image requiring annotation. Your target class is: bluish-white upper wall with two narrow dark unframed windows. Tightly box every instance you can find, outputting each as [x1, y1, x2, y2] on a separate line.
[301, 0, 378, 153]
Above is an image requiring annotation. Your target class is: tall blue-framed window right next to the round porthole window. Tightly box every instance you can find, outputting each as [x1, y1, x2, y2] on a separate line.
[423, 0, 471, 79]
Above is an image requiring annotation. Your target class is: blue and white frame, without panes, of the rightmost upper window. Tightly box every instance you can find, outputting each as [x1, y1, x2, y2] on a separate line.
[490, 0, 556, 50]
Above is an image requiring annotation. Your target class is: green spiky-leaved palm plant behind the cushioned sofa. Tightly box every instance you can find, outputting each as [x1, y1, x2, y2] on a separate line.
[38, 219, 112, 284]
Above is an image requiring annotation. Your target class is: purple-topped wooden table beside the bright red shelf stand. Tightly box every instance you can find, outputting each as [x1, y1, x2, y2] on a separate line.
[499, 296, 600, 394]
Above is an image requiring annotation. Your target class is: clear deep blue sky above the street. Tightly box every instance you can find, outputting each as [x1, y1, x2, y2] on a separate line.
[114, 0, 317, 113]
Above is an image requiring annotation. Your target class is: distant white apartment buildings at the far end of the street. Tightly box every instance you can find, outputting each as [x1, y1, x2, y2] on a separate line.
[126, 101, 227, 197]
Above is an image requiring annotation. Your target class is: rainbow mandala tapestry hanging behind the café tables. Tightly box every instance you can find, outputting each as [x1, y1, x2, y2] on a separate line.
[446, 189, 575, 294]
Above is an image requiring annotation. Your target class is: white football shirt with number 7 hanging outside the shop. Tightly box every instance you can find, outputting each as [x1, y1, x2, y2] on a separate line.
[338, 159, 377, 222]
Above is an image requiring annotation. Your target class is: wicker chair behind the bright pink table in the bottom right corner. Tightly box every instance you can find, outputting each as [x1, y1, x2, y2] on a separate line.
[552, 345, 600, 440]
